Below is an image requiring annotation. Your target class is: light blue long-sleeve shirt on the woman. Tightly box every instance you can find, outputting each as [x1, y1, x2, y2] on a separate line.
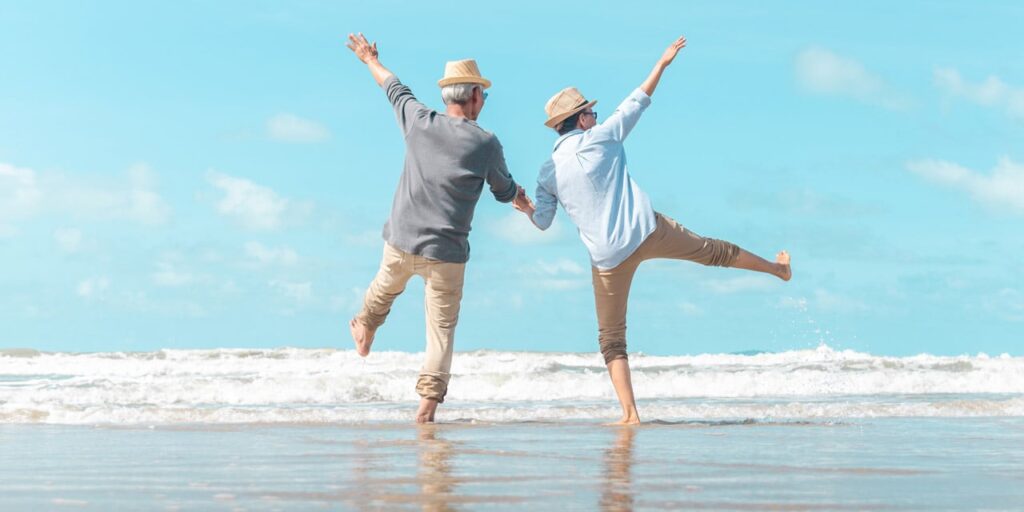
[534, 88, 656, 269]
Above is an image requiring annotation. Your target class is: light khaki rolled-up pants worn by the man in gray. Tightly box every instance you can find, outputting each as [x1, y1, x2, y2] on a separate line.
[355, 244, 466, 401]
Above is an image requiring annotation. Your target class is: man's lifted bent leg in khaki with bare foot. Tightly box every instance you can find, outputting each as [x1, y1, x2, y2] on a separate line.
[348, 244, 413, 357]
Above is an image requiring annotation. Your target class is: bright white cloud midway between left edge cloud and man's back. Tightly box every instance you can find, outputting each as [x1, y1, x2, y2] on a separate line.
[207, 172, 310, 229]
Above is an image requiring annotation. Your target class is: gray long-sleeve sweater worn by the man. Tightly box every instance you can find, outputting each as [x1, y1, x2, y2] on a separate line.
[383, 76, 517, 263]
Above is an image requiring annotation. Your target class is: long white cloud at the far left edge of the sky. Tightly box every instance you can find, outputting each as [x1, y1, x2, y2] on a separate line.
[0, 163, 171, 234]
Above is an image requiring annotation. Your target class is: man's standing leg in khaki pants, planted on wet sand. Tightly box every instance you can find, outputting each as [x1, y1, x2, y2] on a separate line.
[416, 258, 466, 423]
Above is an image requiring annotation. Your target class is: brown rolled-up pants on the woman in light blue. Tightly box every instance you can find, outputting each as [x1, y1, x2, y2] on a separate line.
[591, 213, 739, 364]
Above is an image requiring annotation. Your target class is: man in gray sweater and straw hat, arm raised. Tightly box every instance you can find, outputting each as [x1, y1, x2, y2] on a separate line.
[347, 34, 528, 423]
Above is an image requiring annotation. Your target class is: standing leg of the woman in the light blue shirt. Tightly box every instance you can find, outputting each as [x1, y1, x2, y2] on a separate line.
[591, 260, 640, 424]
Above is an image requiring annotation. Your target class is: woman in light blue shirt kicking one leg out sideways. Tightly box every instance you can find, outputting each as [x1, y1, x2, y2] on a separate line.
[516, 37, 793, 424]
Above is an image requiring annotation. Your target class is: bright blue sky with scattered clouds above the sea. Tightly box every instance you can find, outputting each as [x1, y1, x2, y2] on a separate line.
[0, 1, 1024, 355]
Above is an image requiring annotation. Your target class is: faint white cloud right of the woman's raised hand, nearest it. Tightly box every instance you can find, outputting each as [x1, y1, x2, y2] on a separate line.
[795, 47, 909, 109]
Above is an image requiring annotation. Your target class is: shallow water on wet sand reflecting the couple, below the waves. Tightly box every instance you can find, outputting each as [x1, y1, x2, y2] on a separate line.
[0, 418, 1024, 510]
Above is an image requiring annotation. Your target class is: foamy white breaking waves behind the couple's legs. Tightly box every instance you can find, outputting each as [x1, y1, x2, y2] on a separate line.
[0, 346, 1024, 425]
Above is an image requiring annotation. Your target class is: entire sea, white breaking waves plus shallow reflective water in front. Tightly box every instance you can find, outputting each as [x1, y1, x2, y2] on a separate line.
[0, 346, 1024, 511]
